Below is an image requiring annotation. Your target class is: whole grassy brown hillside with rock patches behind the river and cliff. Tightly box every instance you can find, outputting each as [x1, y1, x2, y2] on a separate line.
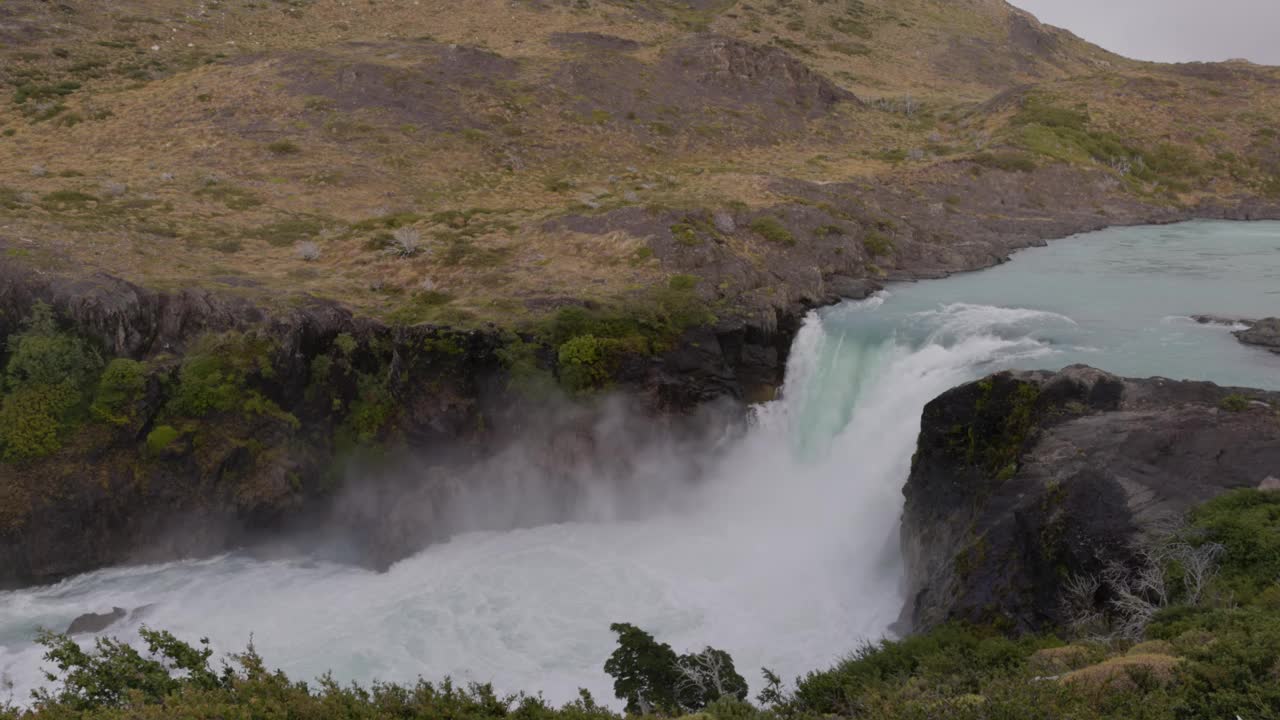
[0, 0, 1280, 325]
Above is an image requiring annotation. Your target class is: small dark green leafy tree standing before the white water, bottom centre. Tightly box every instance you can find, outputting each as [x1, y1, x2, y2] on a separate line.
[604, 623, 681, 715]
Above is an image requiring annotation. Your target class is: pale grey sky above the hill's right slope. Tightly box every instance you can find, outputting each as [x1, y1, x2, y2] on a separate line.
[1010, 0, 1280, 65]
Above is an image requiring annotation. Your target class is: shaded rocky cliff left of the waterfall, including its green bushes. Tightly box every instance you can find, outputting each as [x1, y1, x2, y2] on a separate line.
[0, 266, 800, 587]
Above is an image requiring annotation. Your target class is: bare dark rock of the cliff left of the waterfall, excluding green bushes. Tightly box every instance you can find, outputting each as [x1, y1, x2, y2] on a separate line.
[0, 265, 778, 587]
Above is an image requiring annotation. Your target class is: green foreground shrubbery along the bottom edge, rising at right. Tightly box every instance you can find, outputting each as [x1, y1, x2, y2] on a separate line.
[0, 499, 1280, 720]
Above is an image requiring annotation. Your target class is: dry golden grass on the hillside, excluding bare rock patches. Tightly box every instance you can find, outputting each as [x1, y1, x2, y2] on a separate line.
[0, 0, 1280, 319]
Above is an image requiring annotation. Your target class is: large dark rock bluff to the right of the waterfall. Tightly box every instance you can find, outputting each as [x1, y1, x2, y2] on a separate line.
[902, 366, 1280, 632]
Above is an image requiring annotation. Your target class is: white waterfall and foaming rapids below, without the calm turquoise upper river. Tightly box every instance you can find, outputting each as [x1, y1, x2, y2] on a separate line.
[0, 297, 1070, 702]
